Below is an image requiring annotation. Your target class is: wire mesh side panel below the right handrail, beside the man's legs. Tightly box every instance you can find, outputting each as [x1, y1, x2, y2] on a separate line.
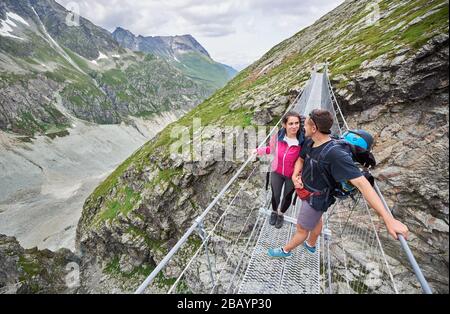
[322, 195, 398, 294]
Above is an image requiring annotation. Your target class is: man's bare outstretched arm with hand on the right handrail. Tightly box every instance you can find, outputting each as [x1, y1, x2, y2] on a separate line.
[350, 176, 408, 240]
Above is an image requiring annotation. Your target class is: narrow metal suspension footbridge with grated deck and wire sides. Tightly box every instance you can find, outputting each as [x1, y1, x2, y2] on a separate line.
[135, 65, 431, 294]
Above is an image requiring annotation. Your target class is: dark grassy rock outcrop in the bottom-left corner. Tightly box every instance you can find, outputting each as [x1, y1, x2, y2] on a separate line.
[0, 235, 79, 294]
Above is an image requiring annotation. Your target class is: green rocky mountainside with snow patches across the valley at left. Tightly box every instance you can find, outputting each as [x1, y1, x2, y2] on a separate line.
[0, 0, 234, 136]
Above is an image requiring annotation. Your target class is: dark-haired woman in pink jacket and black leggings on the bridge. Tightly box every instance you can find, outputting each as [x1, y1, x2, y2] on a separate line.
[256, 111, 305, 228]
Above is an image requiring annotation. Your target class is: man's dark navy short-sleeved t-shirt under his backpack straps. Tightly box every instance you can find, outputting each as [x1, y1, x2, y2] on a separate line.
[300, 138, 363, 192]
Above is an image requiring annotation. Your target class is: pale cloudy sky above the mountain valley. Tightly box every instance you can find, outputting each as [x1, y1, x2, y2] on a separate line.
[56, 0, 344, 71]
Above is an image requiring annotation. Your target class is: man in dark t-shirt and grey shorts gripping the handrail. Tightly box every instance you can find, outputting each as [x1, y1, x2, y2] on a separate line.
[269, 109, 408, 257]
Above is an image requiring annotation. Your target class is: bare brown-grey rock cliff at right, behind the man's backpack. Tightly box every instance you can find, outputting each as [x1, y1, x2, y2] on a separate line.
[337, 34, 449, 292]
